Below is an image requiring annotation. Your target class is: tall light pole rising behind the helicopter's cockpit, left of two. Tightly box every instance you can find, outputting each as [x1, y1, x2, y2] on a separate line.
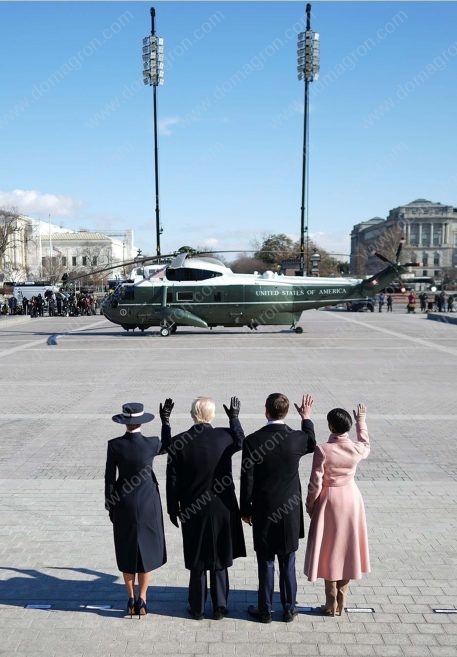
[143, 7, 164, 256]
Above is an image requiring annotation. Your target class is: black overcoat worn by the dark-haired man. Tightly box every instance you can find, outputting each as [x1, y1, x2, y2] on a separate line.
[240, 420, 316, 559]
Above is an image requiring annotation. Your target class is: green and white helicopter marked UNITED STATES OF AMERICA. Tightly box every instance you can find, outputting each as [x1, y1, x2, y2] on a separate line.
[101, 241, 417, 337]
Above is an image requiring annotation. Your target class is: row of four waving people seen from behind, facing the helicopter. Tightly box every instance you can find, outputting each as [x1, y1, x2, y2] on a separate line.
[105, 393, 370, 623]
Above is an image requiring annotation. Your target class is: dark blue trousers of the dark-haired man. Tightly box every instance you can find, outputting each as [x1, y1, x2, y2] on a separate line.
[257, 552, 297, 614]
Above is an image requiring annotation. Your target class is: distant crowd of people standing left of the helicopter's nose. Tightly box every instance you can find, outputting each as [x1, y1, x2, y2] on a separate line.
[1, 290, 97, 317]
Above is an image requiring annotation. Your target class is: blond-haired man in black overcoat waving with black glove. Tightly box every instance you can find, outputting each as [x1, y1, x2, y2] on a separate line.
[162, 397, 246, 620]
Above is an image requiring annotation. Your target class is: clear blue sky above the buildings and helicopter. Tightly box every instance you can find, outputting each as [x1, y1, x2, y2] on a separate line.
[0, 2, 457, 253]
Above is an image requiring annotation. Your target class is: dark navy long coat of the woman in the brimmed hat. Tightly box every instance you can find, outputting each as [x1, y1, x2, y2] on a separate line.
[105, 432, 167, 573]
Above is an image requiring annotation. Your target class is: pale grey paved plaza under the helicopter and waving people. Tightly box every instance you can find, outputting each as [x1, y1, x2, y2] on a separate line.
[0, 309, 457, 657]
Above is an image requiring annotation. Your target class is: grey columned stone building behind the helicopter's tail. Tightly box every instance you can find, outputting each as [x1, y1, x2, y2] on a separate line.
[350, 199, 457, 285]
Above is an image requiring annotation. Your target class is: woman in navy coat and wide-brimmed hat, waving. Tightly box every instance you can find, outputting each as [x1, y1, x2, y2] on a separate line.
[105, 399, 173, 616]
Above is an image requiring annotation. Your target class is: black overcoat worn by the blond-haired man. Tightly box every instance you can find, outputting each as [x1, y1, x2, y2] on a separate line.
[167, 418, 246, 570]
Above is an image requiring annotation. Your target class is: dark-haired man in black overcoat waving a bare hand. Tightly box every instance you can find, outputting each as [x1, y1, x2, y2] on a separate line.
[240, 393, 316, 623]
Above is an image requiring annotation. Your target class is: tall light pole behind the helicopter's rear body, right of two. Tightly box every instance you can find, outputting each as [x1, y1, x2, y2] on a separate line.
[297, 3, 320, 276]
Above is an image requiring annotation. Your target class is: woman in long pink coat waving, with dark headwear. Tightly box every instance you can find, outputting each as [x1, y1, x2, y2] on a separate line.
[305, 404, 370, 616]
